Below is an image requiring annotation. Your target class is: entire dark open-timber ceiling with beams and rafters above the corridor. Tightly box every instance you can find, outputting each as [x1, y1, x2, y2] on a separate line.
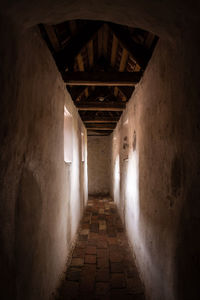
[39, 20, 158, 135]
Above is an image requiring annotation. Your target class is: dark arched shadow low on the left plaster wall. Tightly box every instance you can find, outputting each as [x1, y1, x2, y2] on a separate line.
[15, 169, 42, 299]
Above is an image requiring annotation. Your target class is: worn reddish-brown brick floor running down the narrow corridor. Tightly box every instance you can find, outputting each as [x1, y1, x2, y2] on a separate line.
[55, 197, 145, 300]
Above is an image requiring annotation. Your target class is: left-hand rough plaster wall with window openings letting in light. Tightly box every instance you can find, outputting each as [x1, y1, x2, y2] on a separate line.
[0, 19, 87, 300]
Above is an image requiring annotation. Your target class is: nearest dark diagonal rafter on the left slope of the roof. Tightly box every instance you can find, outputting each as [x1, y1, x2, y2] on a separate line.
[56, 22, 102, 71]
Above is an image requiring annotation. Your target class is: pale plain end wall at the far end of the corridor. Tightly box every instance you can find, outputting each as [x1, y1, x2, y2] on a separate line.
[88, 136, 110, 195]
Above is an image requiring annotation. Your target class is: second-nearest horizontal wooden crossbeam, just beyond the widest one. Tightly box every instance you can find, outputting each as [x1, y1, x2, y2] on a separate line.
[76, 102, 126, 111]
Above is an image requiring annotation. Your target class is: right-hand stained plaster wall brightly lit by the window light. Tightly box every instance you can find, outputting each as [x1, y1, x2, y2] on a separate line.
[111, 33, 200, 300]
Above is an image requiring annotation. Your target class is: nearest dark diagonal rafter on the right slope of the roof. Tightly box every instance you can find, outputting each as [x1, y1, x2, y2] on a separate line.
[108, 23, 151, 70]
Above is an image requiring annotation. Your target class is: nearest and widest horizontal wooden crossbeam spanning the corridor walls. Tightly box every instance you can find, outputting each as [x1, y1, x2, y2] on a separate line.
[62, 72, 142, 86]
